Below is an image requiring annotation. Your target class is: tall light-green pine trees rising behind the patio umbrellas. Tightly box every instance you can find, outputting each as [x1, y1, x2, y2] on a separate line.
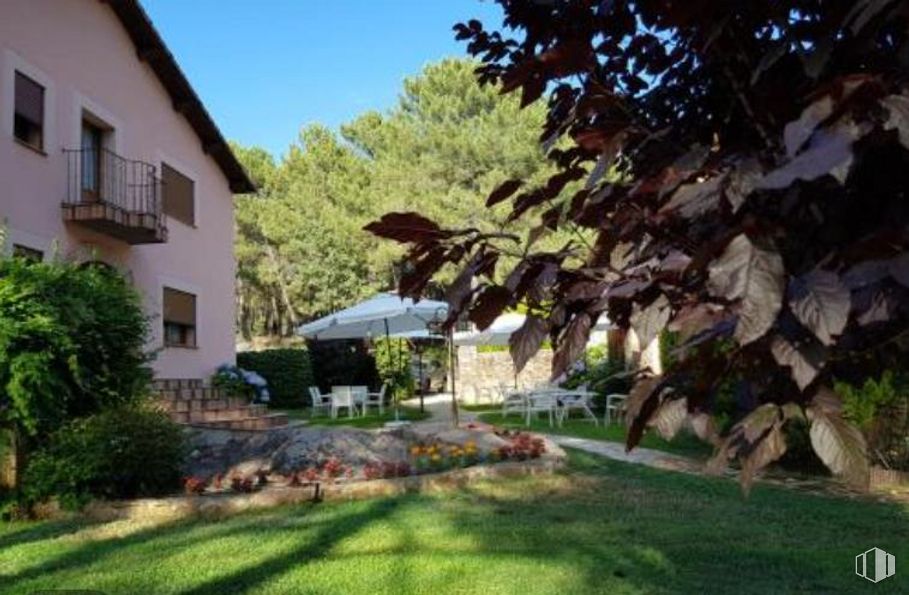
[235, 60, 552, 337]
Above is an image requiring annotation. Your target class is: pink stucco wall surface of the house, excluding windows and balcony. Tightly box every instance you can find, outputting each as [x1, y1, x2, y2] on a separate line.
[0, 0, 235, 378]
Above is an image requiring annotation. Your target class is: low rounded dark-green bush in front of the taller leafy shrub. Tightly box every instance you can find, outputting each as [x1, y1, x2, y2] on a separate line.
[24, 406, 185, 508]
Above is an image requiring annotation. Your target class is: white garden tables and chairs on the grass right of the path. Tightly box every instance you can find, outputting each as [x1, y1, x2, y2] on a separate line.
[500, 386, 628, 427]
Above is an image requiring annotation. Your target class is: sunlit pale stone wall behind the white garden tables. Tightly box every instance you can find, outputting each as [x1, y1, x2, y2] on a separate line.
[457, 345, 552, 405]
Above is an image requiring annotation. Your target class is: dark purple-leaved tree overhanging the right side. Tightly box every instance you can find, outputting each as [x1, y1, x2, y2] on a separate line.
[367, 0, 909, 489]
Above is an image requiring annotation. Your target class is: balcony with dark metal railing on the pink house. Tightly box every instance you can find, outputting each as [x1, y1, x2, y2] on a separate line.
[63, 149, 167, 245]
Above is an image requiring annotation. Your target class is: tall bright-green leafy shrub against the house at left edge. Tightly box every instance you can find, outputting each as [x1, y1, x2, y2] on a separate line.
[0, 258, 151, 438]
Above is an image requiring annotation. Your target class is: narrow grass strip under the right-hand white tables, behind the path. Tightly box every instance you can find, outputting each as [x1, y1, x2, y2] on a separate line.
[479, 407, 713, 459]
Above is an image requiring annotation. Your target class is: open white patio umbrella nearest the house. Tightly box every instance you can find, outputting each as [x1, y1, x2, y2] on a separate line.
[297, 293, 457, 423]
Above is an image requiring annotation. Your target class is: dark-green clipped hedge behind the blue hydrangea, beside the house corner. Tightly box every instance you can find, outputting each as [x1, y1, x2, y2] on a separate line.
[237, 348, 314, 407]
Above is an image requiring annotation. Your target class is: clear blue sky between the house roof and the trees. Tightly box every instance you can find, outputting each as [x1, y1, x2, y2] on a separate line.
[143, 0, 501, 155]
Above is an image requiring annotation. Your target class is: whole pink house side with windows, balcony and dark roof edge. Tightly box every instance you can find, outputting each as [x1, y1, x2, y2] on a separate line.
[0, 0, 254, 378]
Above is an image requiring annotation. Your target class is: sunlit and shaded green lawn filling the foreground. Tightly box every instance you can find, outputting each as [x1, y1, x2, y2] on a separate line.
[0, 453, 909, 595]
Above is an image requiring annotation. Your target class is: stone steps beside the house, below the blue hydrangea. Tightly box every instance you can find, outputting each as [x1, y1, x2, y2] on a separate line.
[153, 378, 288, 430]
